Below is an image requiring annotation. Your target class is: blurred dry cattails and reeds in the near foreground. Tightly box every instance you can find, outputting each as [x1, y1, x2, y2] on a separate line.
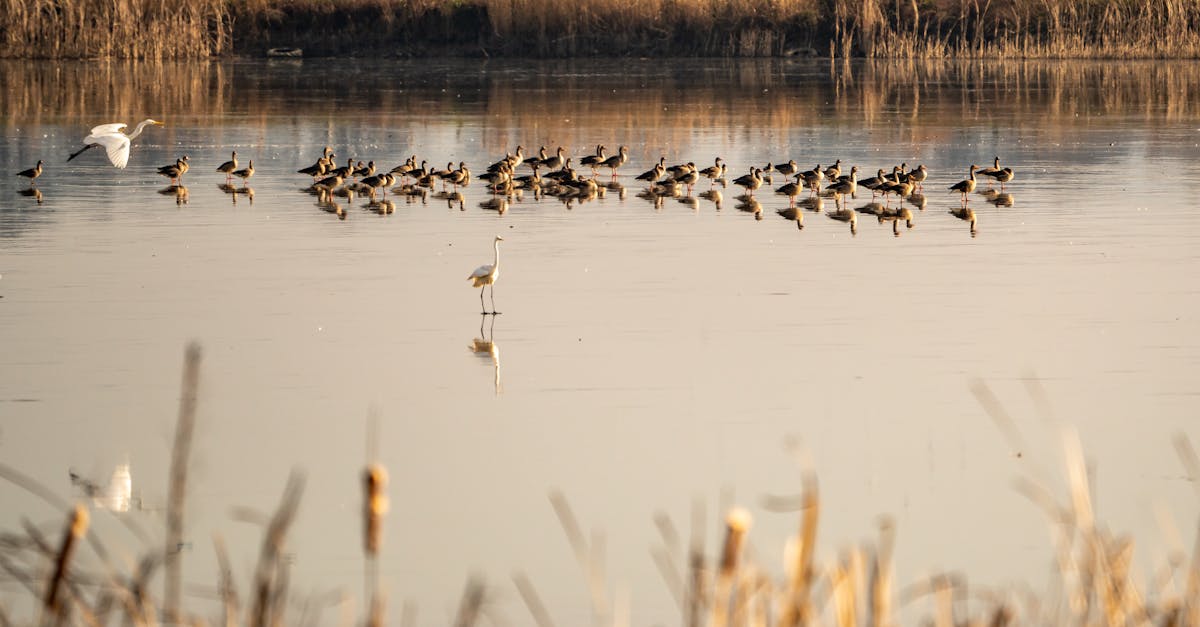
[0, 345, 1200, 627]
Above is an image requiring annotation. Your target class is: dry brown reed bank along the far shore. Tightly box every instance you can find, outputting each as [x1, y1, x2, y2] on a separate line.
[0, 0, 1200, 59]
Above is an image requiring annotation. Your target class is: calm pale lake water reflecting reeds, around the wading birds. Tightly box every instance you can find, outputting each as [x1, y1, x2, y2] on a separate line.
[0, 59, 1200, 625]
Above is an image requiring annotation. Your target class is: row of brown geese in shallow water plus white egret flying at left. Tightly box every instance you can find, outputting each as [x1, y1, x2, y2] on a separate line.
[17, 119, 1014, 235]
